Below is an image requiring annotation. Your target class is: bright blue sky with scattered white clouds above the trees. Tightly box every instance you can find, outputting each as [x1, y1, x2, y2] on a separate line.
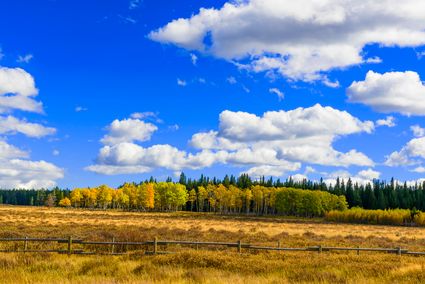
[0, 0, 425, 188]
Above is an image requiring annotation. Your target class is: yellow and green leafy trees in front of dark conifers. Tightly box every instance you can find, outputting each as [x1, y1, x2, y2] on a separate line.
[58, 182, 347, 217]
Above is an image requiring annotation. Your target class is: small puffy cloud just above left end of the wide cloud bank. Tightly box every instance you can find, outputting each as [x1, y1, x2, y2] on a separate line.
[101, 119, 158, 145]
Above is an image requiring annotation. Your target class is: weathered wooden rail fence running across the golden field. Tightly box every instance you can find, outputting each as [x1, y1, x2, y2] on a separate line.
[0, 237, 425, 256]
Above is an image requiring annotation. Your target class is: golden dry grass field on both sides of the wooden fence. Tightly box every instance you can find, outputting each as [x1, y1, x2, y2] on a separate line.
[0, 206, 425, 283]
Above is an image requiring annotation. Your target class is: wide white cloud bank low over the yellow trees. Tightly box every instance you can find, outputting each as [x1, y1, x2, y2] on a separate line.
[87, 105, 374, 176]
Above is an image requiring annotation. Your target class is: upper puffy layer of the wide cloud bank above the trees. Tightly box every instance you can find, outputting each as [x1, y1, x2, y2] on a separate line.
[220, 104, 374, 141]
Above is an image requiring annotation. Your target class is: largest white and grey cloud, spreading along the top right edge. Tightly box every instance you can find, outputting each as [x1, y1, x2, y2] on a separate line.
[149, 0, 425, 81]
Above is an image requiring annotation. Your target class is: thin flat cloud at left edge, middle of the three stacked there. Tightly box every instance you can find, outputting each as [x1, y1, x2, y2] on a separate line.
[0, 115, 56, 138]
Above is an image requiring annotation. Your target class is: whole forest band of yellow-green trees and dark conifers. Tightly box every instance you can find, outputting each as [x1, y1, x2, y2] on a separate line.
[0, 173, 425, 216]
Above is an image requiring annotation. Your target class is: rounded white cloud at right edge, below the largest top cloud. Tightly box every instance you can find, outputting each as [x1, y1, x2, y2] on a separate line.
[347, 71, 425, 116]
